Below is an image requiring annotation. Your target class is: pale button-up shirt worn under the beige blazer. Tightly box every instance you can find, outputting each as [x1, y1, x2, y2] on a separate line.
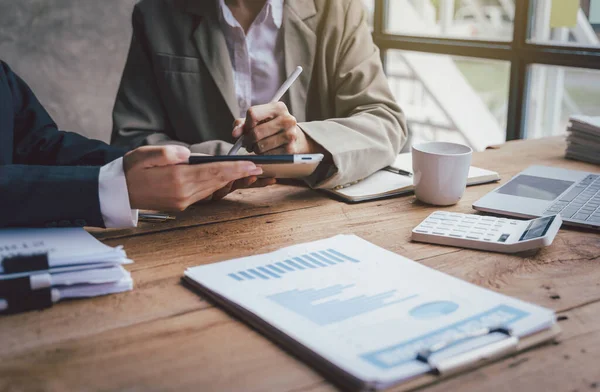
[218, 0, 285, 117]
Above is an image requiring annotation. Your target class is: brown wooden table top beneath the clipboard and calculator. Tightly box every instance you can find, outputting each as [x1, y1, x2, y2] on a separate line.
[0, 138, 600, 392]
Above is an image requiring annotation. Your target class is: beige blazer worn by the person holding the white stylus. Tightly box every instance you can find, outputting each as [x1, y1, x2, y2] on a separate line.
[112, 0, 407, 188]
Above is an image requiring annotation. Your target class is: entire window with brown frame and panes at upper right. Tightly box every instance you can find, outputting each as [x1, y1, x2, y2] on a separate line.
[363, 0, 600, 150]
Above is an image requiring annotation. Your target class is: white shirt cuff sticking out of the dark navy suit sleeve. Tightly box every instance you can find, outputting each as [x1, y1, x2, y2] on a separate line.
[98, 158, 138, 228]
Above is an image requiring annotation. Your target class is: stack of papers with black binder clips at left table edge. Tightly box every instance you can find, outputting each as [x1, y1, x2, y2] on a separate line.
[0, 228, 133, 314]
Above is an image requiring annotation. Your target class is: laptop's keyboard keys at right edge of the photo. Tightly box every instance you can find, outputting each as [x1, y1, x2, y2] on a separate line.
[544, 174, 600, 225]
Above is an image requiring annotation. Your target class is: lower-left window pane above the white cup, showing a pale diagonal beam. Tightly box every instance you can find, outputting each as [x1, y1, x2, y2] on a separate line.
[386, 50, 510, 151]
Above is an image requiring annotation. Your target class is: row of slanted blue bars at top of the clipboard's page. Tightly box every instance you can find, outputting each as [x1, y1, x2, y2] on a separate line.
[228, 249, 360, 282]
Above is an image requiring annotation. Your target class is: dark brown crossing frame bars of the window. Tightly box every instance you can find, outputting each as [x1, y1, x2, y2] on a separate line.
[373, 0, 600, 141]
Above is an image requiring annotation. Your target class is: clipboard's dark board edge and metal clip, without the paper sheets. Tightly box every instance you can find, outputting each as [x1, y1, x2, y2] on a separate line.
[181, 276, 561, 392]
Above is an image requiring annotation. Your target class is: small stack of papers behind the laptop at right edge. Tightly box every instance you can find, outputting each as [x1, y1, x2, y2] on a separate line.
[565, 116, 600, 165]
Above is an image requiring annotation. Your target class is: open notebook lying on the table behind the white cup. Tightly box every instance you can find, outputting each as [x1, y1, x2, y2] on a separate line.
[325, 153, 500, 203]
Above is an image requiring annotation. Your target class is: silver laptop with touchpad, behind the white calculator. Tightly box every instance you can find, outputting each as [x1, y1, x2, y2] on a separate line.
[473, 166, 600, 229]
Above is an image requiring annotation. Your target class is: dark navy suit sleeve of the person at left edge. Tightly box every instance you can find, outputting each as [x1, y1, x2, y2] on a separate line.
[0, 63, 125, 227]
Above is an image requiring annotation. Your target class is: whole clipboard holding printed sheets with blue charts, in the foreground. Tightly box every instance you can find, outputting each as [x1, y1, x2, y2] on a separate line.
[184, 235, 558, 390]
